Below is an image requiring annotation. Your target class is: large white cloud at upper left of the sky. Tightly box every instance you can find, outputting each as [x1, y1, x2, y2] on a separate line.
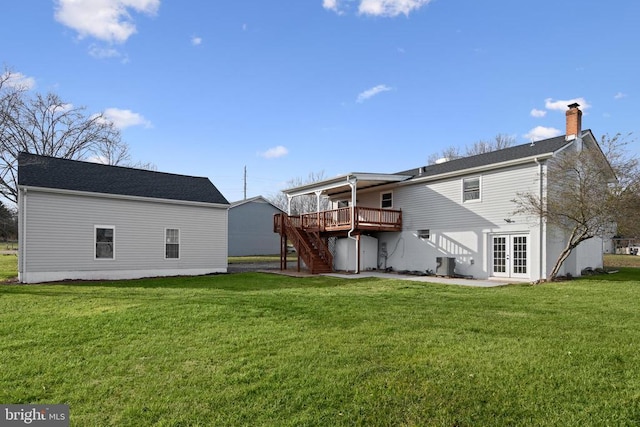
[55, 0, 160, 43]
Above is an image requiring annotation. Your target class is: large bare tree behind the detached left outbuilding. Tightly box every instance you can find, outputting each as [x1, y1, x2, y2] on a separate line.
[0, 70, 135, 203]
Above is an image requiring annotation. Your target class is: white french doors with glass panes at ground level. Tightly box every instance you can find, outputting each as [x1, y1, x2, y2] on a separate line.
[491, 234, 529, 278]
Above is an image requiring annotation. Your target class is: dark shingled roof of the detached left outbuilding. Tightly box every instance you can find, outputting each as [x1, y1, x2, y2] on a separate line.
[18, 153, 229, 204]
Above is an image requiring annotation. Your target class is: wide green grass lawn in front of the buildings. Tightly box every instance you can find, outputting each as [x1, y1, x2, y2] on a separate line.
[0, 268, 640, 426]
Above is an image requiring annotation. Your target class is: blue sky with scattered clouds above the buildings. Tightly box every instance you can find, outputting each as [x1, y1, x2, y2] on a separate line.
[0, 0, 640, 201]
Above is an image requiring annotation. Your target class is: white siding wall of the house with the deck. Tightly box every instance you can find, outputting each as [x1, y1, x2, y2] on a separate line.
[358, 164, 540, 278]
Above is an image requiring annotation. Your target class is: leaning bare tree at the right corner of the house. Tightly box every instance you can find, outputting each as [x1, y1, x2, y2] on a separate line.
[514, 135, 638, 280]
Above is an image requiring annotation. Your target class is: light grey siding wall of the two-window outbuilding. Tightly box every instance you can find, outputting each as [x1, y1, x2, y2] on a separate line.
[21, 190, 227, 275]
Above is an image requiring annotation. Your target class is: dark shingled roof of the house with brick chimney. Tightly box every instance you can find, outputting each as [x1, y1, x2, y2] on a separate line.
[397, 135, 576, 178]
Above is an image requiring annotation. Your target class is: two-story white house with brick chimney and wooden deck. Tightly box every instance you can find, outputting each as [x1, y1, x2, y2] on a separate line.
[274, 104, 603, 281]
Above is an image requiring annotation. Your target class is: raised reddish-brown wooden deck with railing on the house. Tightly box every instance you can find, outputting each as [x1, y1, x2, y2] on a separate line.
[273, 206, 402, 233]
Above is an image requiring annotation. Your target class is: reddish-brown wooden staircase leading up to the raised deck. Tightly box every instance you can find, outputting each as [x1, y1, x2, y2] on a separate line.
[274, 214, 333, 274]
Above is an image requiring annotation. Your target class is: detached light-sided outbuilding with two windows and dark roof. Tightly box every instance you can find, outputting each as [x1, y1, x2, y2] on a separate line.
[18, 153, 229, 283]
